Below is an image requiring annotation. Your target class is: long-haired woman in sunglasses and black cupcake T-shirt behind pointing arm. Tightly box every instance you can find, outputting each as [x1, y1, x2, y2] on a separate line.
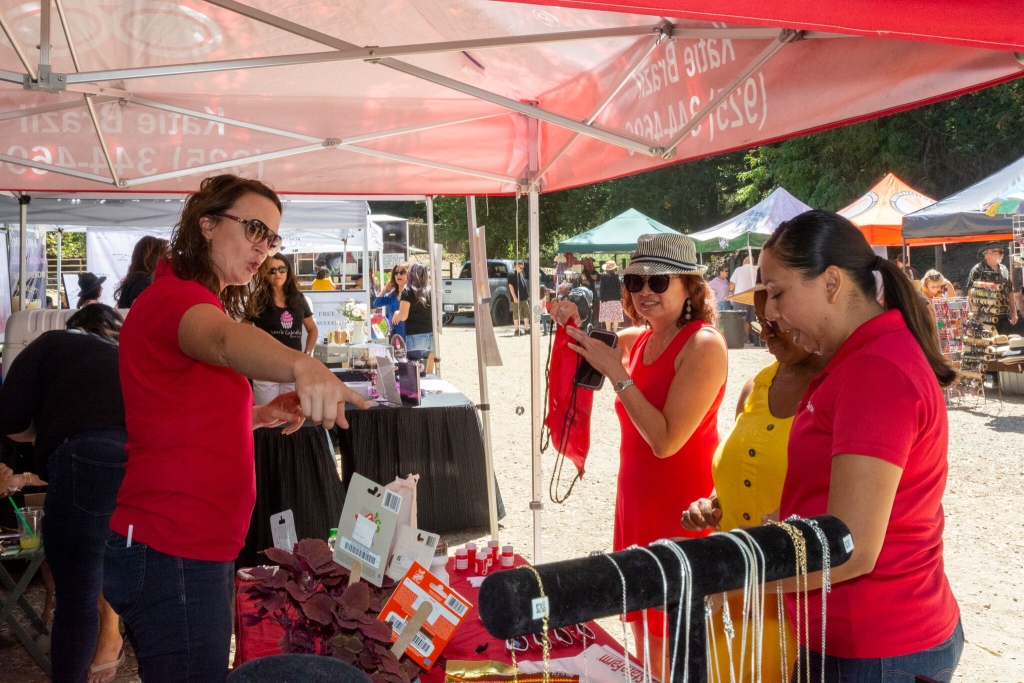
[249, 254, 319, 405]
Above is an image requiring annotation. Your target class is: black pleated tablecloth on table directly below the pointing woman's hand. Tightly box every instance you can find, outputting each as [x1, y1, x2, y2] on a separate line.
[335, 393, 505, 533]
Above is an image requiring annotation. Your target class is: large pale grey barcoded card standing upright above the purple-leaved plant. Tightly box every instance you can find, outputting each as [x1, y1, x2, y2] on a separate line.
[334, 474, 402, 587]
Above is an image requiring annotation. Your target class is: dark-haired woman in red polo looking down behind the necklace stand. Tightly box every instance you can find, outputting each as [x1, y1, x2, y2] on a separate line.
[761, 211, 964, 683]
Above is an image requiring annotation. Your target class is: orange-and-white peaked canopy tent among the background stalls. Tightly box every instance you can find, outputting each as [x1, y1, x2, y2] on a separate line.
[838, 173, 935, 247]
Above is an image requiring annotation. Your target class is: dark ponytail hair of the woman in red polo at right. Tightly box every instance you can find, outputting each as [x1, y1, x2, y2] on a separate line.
[763, 211, 956, 386]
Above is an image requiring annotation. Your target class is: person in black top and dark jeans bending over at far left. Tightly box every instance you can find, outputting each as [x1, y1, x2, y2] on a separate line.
[0, 304, 128, 681]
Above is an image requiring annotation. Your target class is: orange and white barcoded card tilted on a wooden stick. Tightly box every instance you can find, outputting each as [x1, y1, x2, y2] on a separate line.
[377, 562, 473, 669]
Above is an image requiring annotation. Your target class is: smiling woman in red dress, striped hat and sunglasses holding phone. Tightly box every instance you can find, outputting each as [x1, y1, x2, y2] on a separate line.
[552, 233, 729, 677]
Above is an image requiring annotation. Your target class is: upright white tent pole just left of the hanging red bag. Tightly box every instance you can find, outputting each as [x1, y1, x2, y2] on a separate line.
[527, 182, 546, 564]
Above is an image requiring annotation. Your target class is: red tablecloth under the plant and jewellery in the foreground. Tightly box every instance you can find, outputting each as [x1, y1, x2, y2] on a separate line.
[234, 555, 621, 683]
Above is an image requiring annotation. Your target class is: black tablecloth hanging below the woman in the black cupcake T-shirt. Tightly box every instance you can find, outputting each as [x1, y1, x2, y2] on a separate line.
[237, 422, 345, 567]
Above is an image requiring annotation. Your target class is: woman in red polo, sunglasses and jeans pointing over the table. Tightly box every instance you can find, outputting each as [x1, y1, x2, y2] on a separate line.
[103, 175, 366, 683]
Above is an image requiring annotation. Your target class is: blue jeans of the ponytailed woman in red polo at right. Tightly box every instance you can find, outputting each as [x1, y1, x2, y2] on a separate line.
[792, 622, 964, 683]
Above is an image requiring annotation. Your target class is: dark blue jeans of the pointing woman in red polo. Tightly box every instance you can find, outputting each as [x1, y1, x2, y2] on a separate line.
[103, 531, 234, 683]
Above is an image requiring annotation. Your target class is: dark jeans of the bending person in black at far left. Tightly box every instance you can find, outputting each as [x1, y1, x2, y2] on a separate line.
[42, 429, 128, 683]
